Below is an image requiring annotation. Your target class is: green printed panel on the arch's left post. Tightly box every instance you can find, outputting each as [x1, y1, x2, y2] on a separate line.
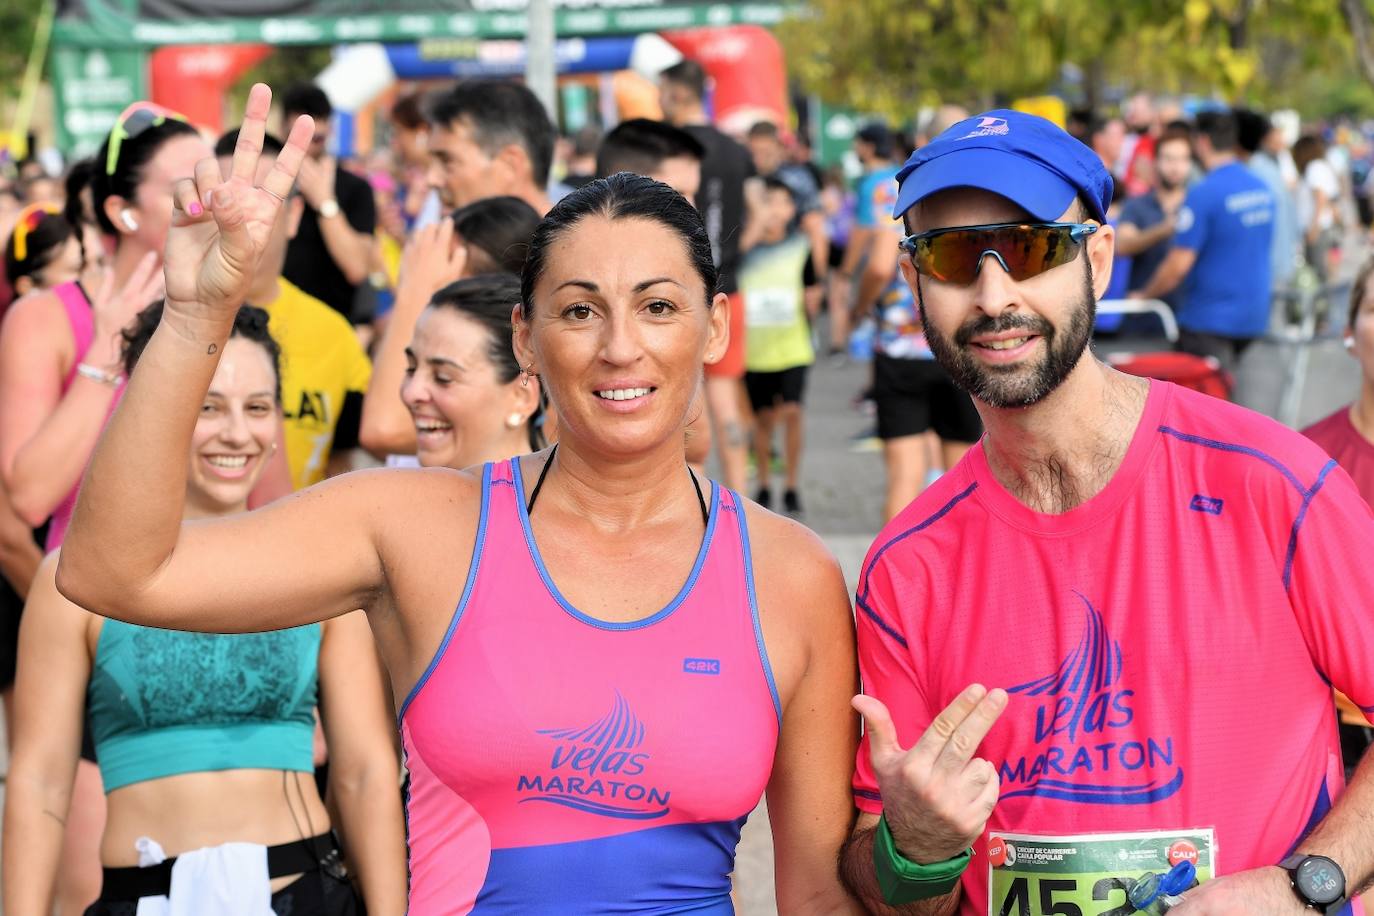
[51, 47, 148, 158]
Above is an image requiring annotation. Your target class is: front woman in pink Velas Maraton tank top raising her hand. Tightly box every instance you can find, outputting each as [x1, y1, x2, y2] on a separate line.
[58, 85, 857, 916]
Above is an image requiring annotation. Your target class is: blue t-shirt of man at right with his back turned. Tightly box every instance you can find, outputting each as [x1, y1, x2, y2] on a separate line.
[1173, 162, 1274, 338]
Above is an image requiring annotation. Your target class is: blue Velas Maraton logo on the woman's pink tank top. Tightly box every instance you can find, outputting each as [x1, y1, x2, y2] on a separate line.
[515, 691, 672, 820]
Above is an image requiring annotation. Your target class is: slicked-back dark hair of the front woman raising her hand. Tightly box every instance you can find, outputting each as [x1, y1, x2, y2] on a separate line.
[519, 172, 720, 319]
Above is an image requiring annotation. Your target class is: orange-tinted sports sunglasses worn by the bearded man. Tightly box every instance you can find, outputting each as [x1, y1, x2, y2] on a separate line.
[901, 222, 1099, 286]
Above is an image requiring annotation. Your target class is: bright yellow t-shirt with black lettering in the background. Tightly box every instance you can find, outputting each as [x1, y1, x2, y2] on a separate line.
[254, 279, 372, 489]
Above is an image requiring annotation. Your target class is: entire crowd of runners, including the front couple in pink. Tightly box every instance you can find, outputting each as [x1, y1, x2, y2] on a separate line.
[0, 62, 1374, 916]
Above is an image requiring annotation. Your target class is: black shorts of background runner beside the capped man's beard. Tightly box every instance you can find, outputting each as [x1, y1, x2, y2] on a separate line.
[872, 353, 982, 442]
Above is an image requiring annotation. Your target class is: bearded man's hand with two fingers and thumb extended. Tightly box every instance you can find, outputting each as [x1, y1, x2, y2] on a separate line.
[853, 684, 1007, 865]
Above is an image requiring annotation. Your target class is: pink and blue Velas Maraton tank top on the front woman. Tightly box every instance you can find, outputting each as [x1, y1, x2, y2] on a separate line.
[400, 461, 780, 916]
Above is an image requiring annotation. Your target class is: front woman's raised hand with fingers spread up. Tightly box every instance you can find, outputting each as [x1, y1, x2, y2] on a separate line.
[164, 82, 315, 321]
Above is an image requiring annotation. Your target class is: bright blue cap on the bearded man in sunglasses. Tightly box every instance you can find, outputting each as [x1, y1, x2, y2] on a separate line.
[892, 108, 1112, 222]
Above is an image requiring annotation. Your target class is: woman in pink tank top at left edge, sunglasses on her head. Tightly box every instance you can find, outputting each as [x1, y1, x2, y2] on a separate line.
[0, 105, 210, 912]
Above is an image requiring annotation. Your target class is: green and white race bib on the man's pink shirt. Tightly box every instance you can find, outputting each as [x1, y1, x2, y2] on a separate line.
[988, 828, 1216, 916]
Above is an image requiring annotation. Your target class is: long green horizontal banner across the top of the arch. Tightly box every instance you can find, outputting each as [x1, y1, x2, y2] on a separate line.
[54, 0, 787, 48]
